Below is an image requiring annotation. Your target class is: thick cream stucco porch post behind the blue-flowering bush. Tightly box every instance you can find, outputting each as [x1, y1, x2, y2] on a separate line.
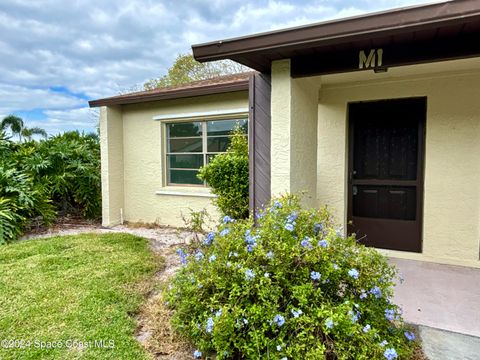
[271, 59, 319, 206]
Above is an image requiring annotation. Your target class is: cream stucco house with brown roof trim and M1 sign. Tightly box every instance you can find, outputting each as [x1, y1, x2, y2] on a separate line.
[91, 0, 480, 267]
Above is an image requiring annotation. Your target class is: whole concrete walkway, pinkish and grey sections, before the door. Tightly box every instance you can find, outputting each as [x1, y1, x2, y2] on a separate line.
[390, 258, 480, 360]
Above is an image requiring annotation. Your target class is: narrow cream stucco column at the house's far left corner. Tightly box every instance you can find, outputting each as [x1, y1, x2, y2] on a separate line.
[100, 106, 124, 227]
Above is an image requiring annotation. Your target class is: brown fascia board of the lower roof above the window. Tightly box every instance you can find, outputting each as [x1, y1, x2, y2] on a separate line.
[88, 79, 249, 107]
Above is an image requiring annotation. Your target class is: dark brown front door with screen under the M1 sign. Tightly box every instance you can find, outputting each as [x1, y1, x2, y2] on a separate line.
[348, 98, 426, 252]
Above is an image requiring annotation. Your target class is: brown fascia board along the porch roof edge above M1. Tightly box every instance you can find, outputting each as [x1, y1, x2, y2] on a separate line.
[192, 0, 480, 62]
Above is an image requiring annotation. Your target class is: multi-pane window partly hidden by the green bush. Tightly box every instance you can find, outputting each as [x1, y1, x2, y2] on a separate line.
[164, 116, 248, 187]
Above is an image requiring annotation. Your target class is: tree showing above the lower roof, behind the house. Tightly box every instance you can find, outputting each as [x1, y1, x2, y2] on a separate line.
[143, 54, 249, 90]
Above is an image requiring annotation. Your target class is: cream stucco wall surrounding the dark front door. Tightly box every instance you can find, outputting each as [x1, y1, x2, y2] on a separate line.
[318, 71, 480, 267]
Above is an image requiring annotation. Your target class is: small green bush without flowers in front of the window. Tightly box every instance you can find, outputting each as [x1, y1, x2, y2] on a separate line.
[198, 129, 249, 219]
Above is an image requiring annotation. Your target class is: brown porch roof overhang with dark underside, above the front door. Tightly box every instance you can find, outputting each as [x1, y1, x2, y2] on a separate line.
[192, 0, 480, 76]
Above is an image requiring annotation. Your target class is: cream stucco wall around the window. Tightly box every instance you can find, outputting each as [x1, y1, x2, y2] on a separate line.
[122, 92, 248, 226]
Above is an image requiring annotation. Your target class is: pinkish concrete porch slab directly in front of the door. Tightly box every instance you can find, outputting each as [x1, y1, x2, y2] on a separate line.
[390, 258, 480, 338]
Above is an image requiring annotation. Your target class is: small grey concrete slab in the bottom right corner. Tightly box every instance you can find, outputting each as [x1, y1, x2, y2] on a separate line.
[419, 326, 480, 360]
